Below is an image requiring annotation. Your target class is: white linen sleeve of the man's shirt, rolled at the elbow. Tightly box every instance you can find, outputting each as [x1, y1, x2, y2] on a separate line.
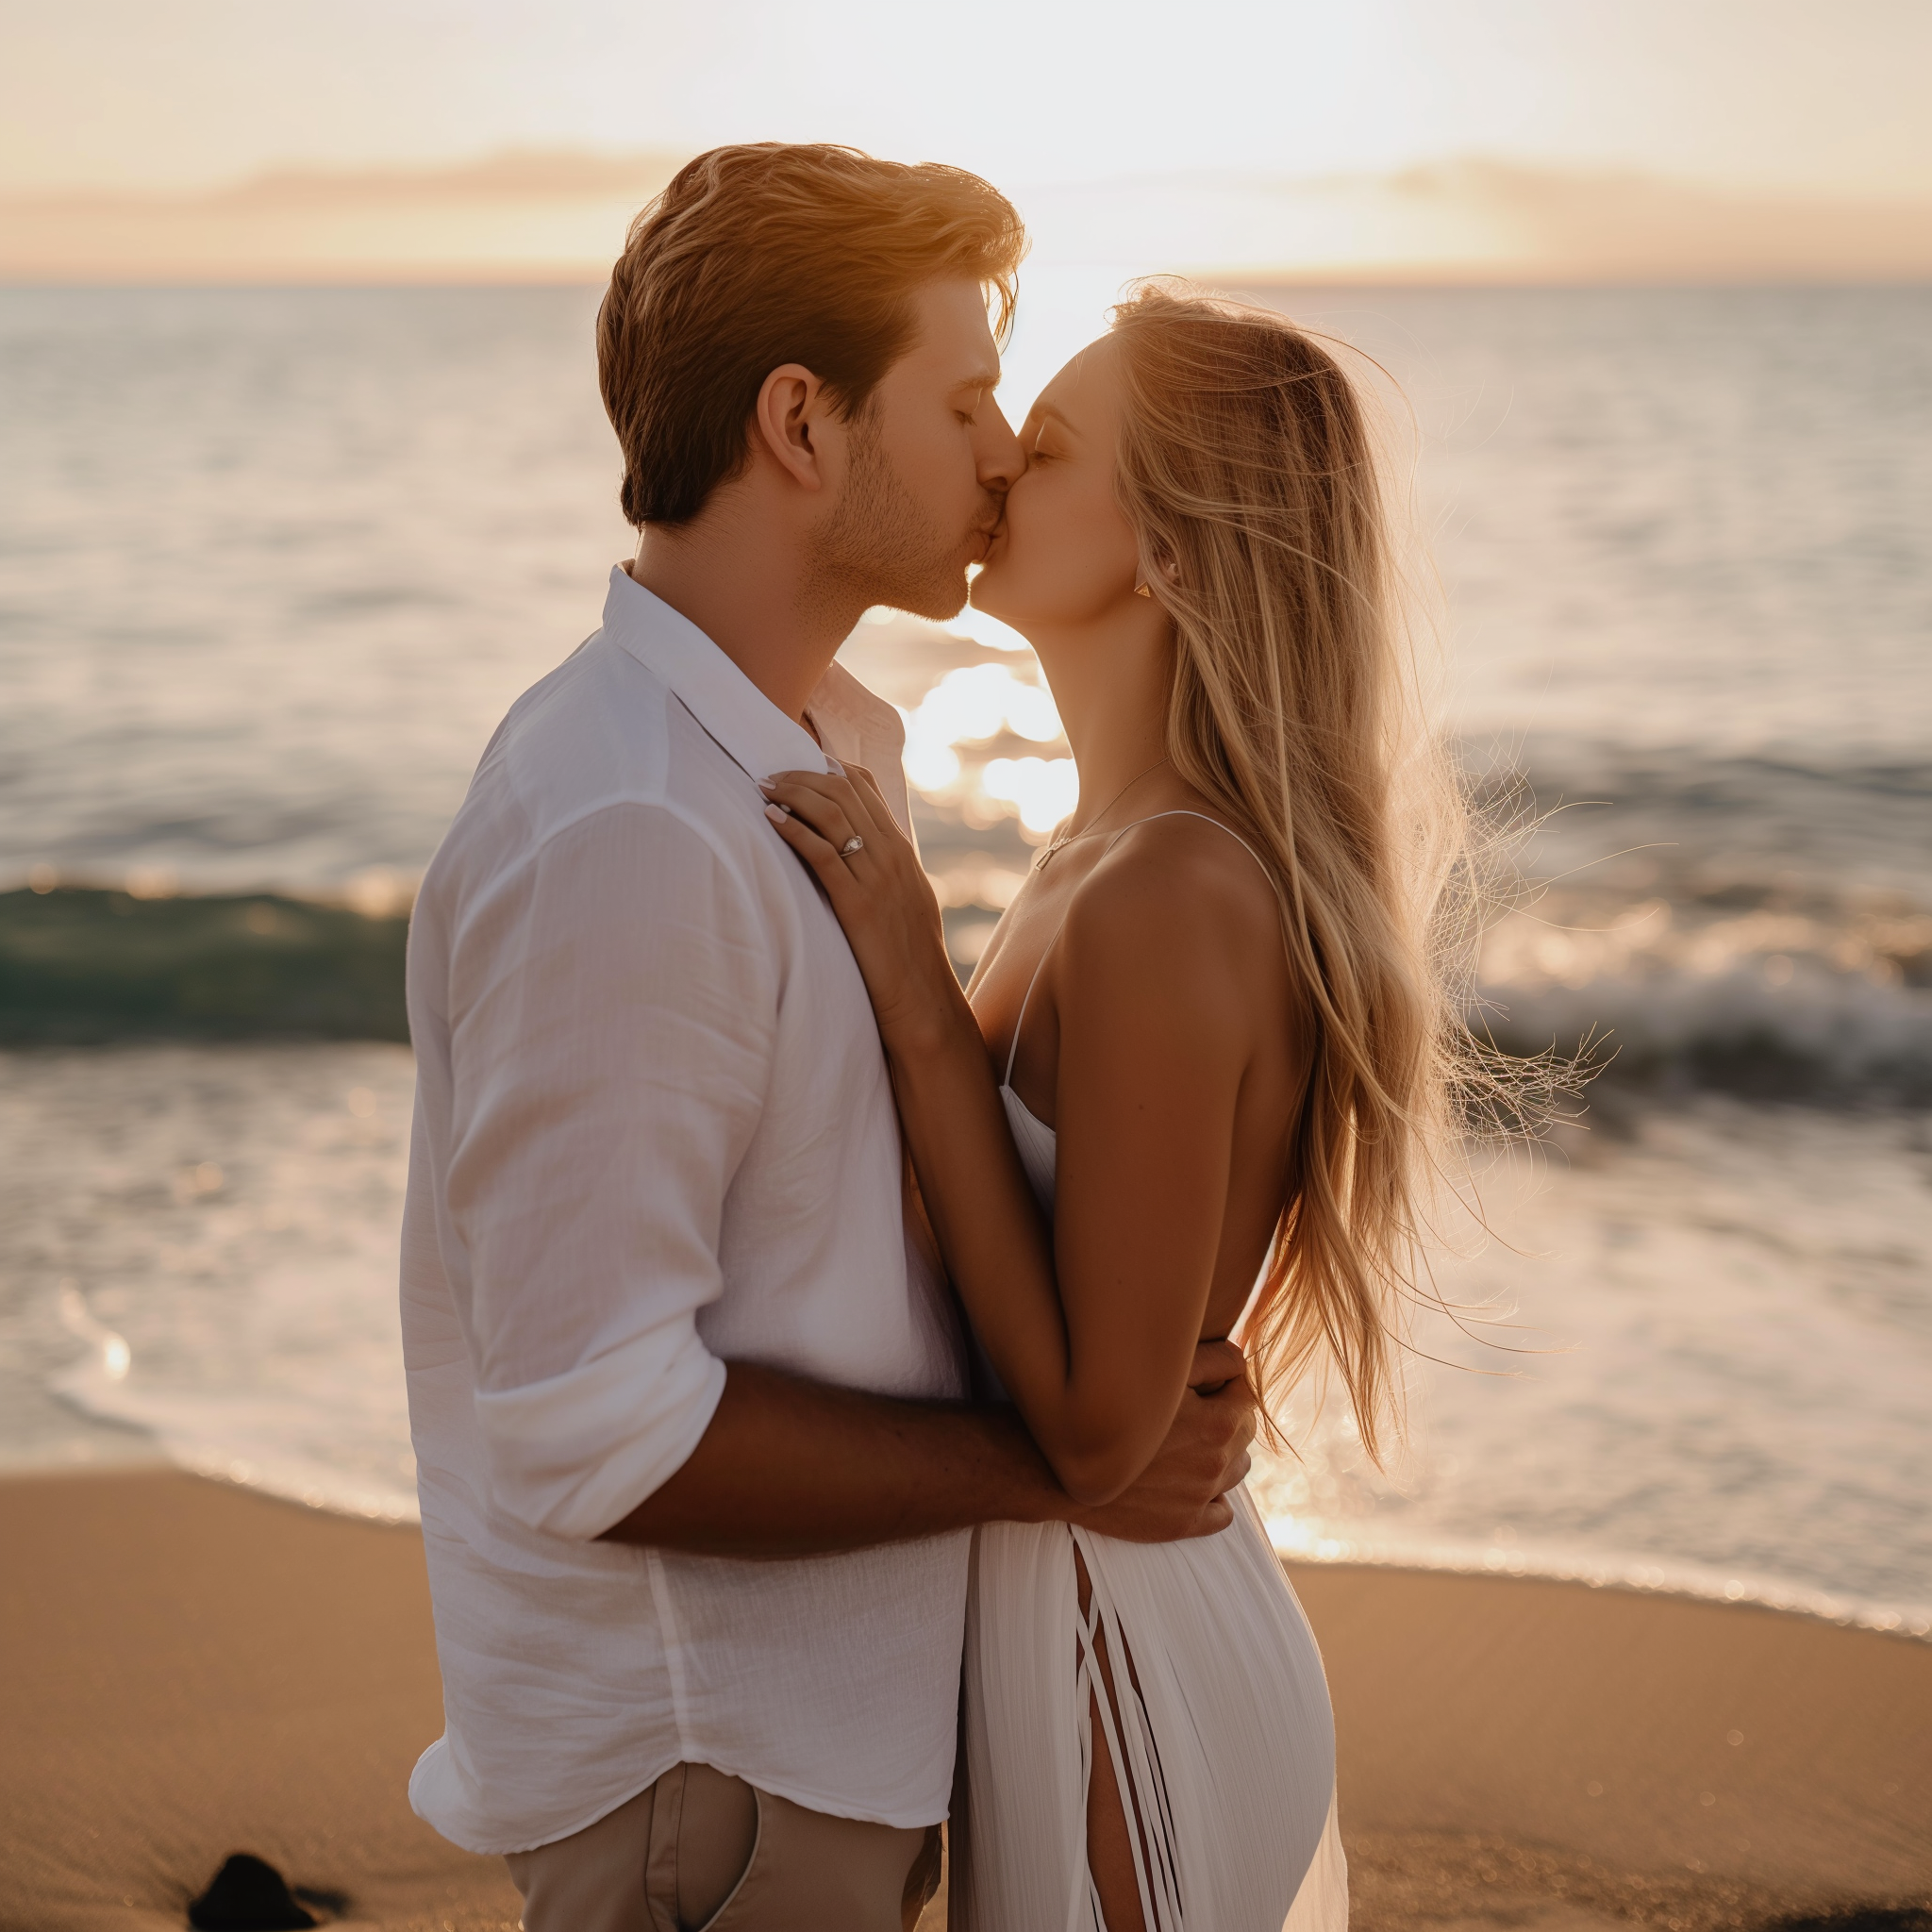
[446, 804, 778, 1538]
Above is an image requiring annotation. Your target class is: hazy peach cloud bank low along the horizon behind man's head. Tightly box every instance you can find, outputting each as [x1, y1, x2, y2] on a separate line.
[0, 151, 1932, 282]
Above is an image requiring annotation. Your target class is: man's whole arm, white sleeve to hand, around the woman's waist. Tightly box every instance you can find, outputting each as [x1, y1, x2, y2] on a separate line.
[442, 806, 1252, 1556]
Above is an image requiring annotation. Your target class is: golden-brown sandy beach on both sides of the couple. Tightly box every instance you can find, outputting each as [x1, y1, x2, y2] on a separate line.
[0, 1471, 1932, 1932]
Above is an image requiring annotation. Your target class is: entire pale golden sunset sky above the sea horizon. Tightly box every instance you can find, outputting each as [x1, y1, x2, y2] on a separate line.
[0, 0, 1932, 276]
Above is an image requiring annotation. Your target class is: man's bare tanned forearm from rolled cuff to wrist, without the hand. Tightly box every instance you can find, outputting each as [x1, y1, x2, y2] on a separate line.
[605, 1362, 1071, 1557]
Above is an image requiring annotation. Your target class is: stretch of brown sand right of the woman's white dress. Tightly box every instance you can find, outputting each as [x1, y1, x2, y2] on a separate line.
[1291, 1567, 1932, 1932]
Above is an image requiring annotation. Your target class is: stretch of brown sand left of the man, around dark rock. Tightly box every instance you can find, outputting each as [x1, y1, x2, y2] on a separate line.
[0, 1471, 518, 1932]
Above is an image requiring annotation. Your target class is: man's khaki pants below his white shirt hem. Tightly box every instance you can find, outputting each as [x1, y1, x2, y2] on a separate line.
[508, 1764, 939, 1932]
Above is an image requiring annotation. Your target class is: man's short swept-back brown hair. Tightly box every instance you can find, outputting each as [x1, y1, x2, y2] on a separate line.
[597, 142, 1025, 525]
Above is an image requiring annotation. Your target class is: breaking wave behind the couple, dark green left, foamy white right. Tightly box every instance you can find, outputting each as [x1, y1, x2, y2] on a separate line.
[0, 889, 1932, 1105]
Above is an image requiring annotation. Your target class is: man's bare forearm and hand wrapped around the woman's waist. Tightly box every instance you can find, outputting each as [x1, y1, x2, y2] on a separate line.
[605, 1342, 1254, 1557]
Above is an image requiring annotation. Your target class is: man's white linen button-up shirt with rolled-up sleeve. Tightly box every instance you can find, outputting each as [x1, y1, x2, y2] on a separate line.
[402, 570, 968, 1853]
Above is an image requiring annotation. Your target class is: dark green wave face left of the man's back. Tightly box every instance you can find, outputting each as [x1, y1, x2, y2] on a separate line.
[0, 887, 409, 1045]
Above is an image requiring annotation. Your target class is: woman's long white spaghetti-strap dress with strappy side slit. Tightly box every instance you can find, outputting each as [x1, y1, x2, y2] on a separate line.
[949, 813, 1349, 1932]
